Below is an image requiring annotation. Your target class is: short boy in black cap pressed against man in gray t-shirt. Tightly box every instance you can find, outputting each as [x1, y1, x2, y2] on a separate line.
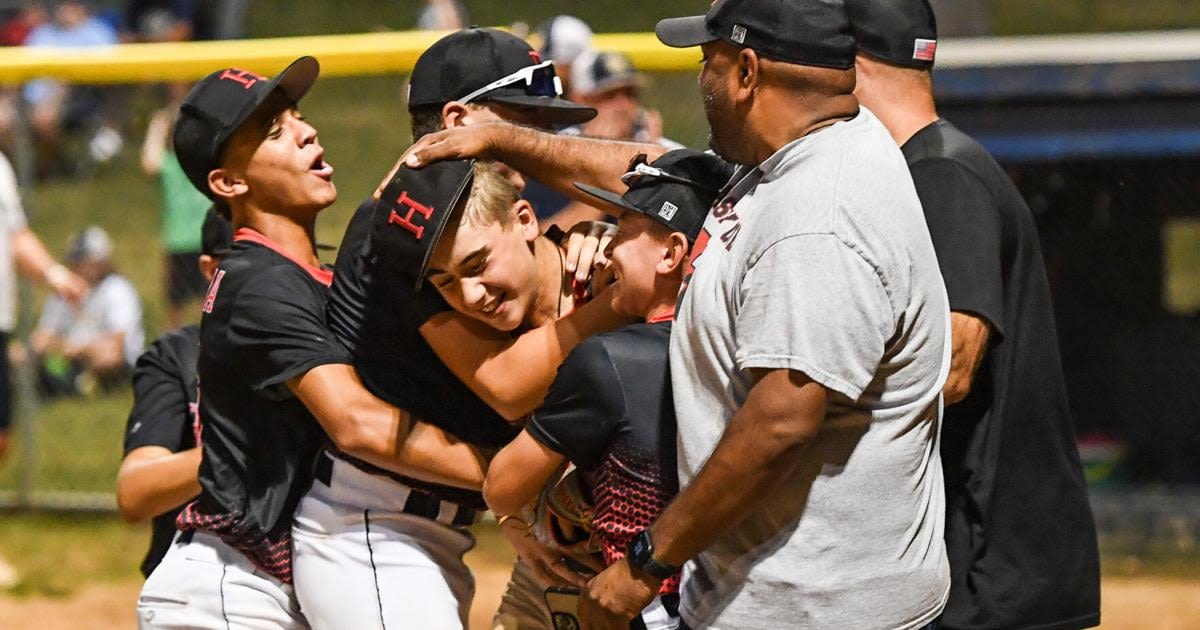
[484, 150, 728, 629]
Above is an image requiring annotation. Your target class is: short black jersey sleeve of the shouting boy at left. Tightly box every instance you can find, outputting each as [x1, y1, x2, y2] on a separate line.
[228, 265, 350, 396]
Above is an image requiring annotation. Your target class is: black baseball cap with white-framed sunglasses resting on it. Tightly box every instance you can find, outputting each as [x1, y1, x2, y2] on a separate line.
[408, 28, 596, 125]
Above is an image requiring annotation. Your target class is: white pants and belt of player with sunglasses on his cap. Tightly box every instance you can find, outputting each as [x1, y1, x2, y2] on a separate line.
[292, 458, 475, 630]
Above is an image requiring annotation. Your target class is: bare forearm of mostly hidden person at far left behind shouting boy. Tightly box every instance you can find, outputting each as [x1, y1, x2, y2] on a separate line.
[116, 446, 200, 523]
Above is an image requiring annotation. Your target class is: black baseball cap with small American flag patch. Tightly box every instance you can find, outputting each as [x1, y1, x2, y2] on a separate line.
[846, 0, 937, 70]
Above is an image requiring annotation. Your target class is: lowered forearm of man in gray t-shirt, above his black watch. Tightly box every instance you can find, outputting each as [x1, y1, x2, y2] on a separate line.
[650, 370, 826, 564]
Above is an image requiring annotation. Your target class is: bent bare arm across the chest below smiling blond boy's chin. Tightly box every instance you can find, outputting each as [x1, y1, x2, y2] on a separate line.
[420, 286, 625, 420]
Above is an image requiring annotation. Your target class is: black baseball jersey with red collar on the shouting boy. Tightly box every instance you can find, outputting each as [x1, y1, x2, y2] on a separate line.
[178, 228, 350, 583]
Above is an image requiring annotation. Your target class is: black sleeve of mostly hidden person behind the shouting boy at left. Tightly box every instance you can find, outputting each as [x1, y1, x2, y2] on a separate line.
[125, 340, 194, 455]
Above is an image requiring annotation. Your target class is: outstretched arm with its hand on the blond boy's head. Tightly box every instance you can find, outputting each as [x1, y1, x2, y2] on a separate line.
[398, 122, 667, 204]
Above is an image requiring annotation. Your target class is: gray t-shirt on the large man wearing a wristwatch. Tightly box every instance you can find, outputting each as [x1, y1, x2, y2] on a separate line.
[671, 108, 950, 630]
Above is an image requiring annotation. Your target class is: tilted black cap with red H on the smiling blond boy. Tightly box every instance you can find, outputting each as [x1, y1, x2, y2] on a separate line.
[371, 160, 475, 288]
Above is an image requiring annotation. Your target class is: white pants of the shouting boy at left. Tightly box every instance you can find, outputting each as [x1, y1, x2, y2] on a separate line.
[138, 532, 308, 630]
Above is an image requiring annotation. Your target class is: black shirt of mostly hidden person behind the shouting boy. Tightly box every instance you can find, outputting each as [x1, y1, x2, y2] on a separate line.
[125, 326, 200, 577]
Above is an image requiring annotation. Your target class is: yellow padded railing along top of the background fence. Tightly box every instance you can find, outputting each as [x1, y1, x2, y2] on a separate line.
[0, 31, 700, 84]
